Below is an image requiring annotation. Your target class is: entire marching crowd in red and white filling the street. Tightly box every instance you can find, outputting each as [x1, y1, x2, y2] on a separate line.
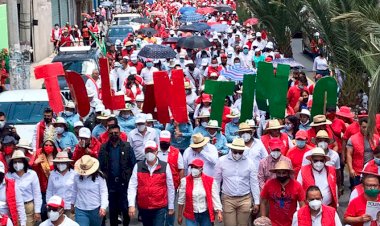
[0, 0, 380, 226]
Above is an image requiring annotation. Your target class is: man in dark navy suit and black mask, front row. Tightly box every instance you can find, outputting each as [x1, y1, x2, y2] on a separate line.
[99, 125, 136, 226]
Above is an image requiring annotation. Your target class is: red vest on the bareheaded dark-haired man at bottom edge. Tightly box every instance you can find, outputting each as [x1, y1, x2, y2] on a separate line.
[297, 205, 336, 226]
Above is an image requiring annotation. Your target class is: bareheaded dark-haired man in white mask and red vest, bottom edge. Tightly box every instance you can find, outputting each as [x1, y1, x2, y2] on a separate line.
[292, 186, 342, 226]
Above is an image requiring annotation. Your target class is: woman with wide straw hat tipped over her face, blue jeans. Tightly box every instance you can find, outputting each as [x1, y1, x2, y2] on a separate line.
[71, 155, 108, 226]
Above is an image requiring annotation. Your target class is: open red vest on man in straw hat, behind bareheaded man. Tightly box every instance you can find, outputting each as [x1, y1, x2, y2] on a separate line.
[301, 164, 338, 208]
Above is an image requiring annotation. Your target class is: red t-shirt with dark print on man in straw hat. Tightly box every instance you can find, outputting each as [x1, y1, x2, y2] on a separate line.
[261, 179, 305, 226]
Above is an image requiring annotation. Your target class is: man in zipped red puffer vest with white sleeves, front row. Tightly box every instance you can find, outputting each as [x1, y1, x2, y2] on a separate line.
[128, 140, 175, 226]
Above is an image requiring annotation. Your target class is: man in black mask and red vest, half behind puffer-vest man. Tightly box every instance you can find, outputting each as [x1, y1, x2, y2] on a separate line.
[157, 130, 184, 226]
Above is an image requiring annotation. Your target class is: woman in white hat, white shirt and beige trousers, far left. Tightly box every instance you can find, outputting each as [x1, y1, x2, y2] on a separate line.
[7, 150, 42, 226]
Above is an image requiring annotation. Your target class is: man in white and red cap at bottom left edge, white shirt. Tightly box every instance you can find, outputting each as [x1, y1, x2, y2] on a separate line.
[40, 195, 79, 226]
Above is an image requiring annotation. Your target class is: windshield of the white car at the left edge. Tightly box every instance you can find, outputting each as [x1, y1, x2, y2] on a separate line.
[0, 101, 49, 125]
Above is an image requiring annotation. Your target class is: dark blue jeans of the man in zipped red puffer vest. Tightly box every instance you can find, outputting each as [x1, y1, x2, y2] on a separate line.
[137, 207, 168, 226]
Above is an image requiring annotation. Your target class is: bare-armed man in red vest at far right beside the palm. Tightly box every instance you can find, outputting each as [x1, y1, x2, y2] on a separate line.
[346, 118, 379, 188]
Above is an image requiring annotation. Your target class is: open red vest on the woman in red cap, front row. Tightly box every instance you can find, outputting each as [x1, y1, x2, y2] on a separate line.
[183, 174, 215, 222]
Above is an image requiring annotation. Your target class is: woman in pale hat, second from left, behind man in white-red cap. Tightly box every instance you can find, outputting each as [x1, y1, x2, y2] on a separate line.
[46, 151, 76, 220]
